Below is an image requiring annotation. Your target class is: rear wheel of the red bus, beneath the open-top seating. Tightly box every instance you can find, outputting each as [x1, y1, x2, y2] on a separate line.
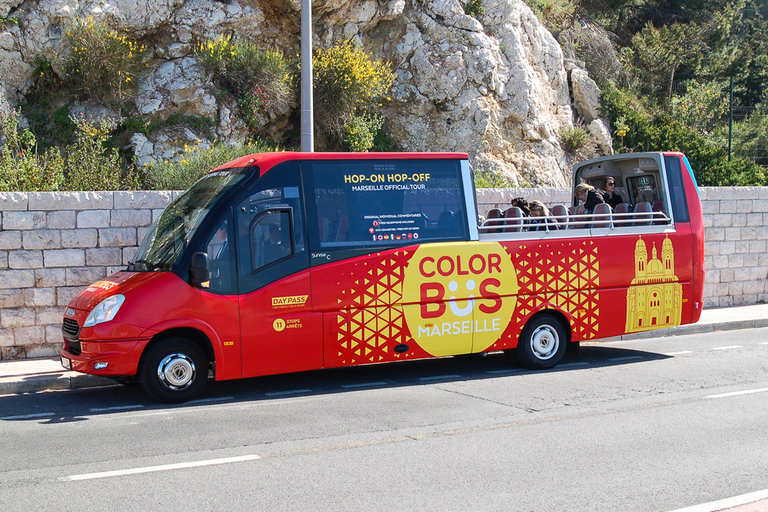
[515, 313, 568, 370]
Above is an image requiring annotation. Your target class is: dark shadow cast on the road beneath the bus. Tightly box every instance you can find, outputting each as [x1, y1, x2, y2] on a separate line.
[0, 345, 670, 425]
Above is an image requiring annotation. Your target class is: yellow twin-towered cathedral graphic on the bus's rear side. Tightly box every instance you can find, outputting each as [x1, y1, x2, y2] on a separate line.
[626, 236, 683, 332]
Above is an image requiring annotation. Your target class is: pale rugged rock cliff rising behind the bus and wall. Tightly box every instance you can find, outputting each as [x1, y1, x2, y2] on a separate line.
[0, 0, 610, 186]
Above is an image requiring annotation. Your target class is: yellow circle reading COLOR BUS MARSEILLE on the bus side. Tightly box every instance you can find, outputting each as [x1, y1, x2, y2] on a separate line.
[403, 242, 519, 356]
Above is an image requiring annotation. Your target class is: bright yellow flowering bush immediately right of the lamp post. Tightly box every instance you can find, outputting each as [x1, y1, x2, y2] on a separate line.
[313, 41, 395, 149]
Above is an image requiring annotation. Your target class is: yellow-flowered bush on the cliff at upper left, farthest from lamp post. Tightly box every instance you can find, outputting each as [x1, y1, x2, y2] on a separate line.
[63, 18, 147, 106]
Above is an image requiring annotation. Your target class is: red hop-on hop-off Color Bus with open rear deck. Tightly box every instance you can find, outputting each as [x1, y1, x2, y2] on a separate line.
[61, 152, 704, 402]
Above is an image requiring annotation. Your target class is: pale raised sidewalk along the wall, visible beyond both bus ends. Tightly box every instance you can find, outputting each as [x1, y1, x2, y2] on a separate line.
[0, 304, 768, 395]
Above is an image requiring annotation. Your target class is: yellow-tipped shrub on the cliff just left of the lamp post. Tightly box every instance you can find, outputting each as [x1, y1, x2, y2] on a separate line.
[197, 36, 291, 130]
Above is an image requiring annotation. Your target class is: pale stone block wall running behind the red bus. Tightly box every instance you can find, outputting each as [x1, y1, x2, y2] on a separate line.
[0, 187, 768, 359]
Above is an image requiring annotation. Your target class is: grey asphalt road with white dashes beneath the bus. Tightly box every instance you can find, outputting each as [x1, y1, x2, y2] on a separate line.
[0, 329, 768, 512]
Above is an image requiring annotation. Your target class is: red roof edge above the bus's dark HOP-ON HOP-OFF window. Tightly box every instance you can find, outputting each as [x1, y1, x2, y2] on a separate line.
[212, 151, 469, 174]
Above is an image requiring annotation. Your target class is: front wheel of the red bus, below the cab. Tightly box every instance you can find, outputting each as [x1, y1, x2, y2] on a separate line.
[140, 338, 208, 403]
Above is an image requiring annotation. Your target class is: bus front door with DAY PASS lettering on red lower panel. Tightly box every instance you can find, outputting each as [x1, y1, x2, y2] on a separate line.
[235, 162, 323, 377]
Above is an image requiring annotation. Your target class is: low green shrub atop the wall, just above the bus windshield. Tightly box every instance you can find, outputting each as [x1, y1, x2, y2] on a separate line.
[145, 138, 276, 190]
